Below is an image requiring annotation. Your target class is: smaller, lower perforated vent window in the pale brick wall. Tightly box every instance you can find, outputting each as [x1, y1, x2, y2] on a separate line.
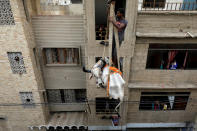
[20, 92, 34, 107]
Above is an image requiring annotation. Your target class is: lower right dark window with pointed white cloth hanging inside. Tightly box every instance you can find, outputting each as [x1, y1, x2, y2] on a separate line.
[139, 92, 190, 111]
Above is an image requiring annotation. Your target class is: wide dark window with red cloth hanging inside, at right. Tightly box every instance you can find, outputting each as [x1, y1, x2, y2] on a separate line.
[146, 44, 197, 69]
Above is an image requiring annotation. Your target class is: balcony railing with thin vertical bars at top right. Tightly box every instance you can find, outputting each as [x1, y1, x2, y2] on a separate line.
[138, 2, 197, 11]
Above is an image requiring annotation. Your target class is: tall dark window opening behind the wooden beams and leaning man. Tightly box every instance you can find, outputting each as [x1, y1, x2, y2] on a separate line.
[95, 0, 126, 40]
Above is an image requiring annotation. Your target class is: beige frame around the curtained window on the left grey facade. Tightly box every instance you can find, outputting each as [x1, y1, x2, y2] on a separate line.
[41, 46, 81, 67]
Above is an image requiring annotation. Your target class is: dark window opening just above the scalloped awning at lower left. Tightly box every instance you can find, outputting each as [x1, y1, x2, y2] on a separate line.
[47, 89, 86, 103]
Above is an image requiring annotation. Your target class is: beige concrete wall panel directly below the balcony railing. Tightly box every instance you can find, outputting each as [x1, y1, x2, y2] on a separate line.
[136, 12, 197, 37]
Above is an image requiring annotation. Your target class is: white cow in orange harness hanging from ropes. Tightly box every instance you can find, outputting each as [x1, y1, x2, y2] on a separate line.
[84, 57, 125, 101]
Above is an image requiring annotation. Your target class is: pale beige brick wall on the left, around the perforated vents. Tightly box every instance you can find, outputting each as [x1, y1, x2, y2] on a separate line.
[0, 0, 47, 131]
